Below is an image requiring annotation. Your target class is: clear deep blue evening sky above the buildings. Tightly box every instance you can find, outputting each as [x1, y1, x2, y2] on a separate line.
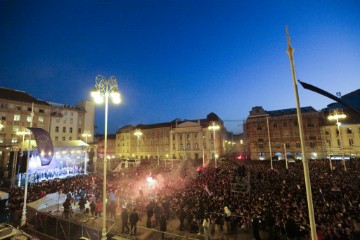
[0, 0, 360, 133]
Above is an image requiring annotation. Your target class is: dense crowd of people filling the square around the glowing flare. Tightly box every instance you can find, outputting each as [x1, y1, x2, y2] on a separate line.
[3, 157, 360, 240]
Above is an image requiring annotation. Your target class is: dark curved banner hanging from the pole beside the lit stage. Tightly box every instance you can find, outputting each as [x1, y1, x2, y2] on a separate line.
[27, 127, 54, 166]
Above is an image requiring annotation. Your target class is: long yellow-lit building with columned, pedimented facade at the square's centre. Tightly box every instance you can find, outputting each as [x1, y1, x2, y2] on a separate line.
[116, 113, 226, 162]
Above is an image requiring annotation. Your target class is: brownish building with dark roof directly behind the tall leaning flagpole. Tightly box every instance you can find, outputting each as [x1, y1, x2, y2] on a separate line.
[244, 107, 326, 160]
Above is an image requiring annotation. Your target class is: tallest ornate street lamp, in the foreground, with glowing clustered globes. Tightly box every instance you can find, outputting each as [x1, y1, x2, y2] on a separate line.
[91, 75, 121, 240]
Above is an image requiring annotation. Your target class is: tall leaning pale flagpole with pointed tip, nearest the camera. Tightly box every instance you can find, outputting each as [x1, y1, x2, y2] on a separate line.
[286, 26, 317, 240]
